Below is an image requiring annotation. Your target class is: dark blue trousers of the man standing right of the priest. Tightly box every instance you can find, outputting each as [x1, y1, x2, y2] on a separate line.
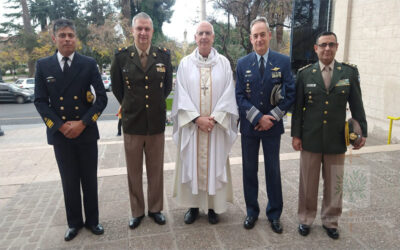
[242, 135, 283, 220]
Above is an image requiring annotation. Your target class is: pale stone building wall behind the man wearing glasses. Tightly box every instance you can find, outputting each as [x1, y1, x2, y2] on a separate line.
[332, 0, 400, 143]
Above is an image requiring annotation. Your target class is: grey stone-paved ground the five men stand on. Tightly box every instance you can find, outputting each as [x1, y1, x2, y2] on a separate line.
[0, 117, 400, 250]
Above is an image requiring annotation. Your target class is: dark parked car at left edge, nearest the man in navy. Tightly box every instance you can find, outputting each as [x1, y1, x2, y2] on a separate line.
[0, 83, 35, 103]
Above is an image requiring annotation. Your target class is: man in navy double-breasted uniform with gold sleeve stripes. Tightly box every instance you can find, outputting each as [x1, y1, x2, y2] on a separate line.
[34, 19, 107, 241]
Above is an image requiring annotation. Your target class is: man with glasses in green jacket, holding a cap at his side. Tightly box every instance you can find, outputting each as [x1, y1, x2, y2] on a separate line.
[291, 32, 367, 239]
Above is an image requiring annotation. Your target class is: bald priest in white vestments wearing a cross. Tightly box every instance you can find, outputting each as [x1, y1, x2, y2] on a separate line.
[172, 21, 238, 224]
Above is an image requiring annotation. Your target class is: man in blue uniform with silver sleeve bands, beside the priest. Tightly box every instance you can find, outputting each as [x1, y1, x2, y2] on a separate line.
[236, 17, 295, 233]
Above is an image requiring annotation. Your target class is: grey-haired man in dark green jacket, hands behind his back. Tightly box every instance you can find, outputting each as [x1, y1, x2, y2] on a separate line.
[111, 12, 172, 229]
